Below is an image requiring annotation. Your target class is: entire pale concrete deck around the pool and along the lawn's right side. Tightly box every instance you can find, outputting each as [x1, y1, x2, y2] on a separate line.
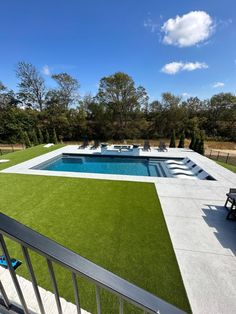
[1, 146, 236, 314]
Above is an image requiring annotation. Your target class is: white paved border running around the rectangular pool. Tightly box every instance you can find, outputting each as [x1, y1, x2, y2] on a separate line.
[1, 145, 234, 183]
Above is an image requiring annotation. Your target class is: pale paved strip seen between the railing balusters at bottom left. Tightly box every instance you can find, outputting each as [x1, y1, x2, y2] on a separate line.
[0, 267, 90, 314]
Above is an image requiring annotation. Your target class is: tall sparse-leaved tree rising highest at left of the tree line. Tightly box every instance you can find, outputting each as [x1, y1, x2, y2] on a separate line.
[16, 62, 46, 111]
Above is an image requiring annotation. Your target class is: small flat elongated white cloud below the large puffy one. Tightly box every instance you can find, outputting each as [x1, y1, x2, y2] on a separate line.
[161, 62, 208, 74]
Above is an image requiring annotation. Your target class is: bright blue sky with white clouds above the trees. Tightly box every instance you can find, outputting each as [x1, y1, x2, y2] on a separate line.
[0, 0, 236, 100]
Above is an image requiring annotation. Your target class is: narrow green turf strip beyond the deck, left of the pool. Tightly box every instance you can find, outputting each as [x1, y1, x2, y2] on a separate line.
[0, 144, 64, 170]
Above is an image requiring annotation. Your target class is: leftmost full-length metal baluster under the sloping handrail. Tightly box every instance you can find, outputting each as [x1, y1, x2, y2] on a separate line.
[0, 234, 29, 314]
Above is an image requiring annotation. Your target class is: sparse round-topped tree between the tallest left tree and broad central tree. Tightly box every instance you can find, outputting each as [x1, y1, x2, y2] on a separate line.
[49, 73, 80, 109]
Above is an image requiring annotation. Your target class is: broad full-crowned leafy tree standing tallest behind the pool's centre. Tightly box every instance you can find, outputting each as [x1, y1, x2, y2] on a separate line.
[96, 72, 148, 139]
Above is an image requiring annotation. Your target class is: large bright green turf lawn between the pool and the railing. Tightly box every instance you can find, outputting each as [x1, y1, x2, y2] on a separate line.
[0, 147, 190, 314]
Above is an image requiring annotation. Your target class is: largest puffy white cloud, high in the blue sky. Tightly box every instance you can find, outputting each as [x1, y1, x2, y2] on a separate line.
[161, 11, 214, 47]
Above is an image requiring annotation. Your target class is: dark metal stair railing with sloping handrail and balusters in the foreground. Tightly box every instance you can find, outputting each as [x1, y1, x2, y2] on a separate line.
[0, 213, 183, 314]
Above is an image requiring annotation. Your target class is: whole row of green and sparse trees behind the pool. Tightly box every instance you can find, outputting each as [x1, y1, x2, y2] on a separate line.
[0, 62, 236, 145]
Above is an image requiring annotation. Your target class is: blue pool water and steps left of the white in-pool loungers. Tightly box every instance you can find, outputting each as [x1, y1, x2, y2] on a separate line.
[34, 155, 169, 177]
